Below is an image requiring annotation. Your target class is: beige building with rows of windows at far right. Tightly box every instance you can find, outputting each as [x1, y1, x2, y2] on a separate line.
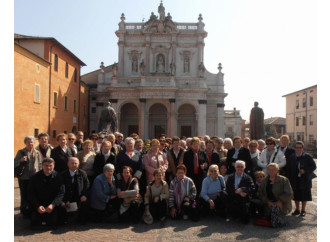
[283, 85, 317, 144]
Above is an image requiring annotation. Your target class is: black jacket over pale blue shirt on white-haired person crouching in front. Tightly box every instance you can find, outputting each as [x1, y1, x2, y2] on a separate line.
[226, 172, 255, 199]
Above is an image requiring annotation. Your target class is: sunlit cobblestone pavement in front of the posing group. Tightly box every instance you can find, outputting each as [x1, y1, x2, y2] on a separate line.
[14, 166, 317, 241]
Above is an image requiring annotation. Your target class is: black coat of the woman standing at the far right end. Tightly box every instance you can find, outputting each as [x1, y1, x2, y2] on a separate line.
[286, 152, 316, 190]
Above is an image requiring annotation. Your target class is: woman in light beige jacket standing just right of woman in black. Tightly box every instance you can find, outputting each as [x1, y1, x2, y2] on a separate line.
[77, 139, 96, 184]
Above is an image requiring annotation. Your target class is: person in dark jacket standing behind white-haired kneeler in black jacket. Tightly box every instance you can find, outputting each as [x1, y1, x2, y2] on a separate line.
[226, 136, 252, 174]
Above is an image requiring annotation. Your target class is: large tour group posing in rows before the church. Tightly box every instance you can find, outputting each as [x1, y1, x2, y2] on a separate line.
[14, 131, 316, 228]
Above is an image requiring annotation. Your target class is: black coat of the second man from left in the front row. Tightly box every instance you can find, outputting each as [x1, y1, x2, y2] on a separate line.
[61, 169, 90, 204]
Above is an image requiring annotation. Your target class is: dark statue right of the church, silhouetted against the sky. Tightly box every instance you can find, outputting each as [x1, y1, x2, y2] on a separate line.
[250, 102, 264, 140]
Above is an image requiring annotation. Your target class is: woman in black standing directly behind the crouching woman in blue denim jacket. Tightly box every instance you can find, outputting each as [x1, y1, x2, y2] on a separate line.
[93, 141, 116, 175]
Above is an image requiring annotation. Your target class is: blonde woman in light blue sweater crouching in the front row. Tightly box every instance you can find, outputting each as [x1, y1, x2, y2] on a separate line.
[199, 165, 227, 217]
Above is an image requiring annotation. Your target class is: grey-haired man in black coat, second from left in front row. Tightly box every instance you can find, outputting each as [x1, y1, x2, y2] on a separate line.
[61, 157, 89, 224]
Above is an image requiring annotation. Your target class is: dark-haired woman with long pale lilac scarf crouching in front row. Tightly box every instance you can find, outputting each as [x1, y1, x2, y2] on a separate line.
[169, 164, 197, 220]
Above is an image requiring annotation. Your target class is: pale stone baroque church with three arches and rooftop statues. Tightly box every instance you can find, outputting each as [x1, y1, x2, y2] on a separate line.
[81, 2, 241, 139]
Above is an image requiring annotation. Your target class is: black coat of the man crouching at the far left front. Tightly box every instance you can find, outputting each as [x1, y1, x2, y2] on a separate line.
[28, 170, 65, 210]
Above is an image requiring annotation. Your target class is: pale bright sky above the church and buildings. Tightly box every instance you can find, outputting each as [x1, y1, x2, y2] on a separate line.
[14, 0, 317, 121]
